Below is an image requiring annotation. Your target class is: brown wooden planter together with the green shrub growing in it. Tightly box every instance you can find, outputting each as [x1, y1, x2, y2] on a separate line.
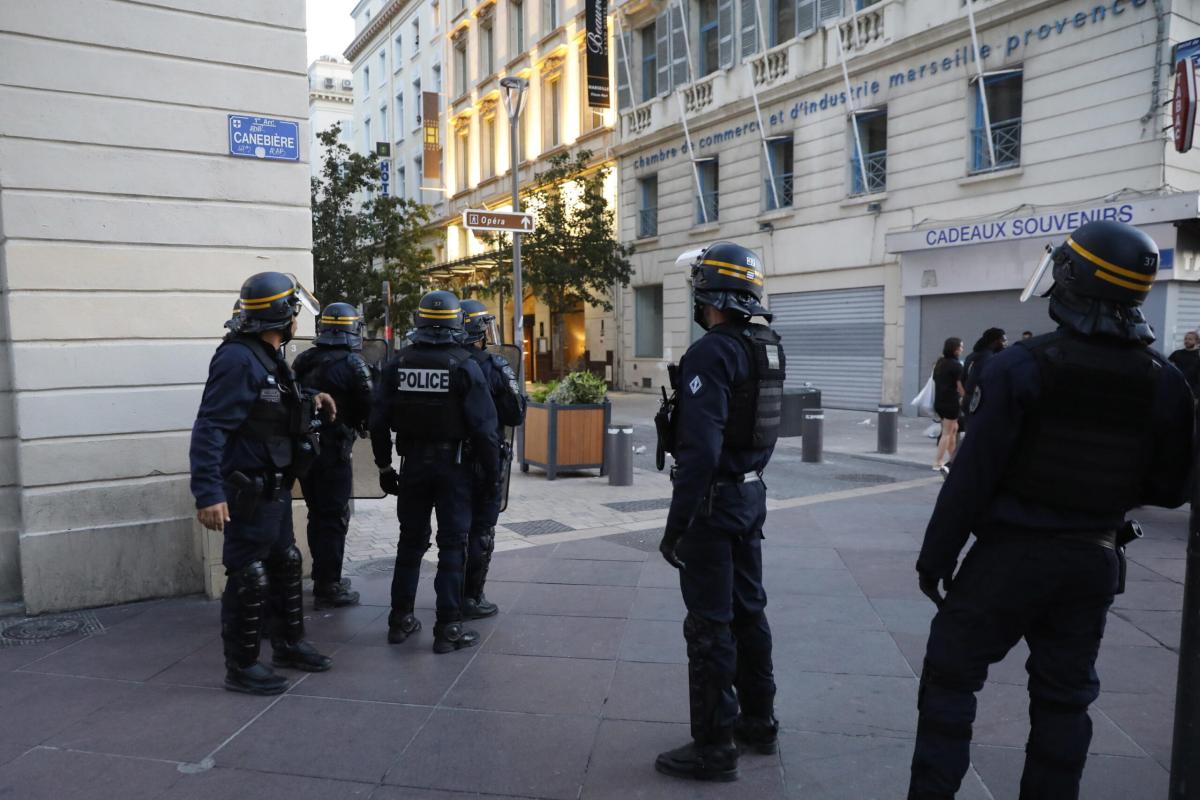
[521, 372, 612, 480]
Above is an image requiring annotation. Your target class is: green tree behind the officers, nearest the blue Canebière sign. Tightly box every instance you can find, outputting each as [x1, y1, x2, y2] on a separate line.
[311, 122, 433, 331]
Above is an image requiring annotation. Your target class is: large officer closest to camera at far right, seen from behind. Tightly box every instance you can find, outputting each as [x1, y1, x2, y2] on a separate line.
[908, 221, 1193, 800]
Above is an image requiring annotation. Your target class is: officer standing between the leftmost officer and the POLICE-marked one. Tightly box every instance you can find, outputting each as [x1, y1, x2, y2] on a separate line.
[293, 302, 373, 609]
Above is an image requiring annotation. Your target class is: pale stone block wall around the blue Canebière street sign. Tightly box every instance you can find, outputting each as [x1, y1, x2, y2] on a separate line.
[0, 0, 312, 612]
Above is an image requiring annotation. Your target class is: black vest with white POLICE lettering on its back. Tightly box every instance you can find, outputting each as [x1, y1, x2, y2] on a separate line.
[384, 344, 470, 445]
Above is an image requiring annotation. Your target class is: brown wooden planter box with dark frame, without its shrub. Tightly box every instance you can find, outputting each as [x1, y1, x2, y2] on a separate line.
[521, 401, 612, 481]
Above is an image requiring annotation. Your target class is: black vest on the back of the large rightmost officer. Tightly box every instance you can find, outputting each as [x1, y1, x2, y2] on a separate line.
[1003, 332, 1163, 515]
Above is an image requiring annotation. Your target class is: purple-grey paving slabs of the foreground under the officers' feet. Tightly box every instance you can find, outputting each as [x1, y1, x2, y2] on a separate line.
[0, 481, 1186, 800]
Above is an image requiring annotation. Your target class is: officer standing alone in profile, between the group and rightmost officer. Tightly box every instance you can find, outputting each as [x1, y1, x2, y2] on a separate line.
[655, 242, 785, 781]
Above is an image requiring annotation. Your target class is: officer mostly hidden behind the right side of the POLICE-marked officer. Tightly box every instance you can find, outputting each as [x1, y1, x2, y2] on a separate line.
[453, 299, 526, 619]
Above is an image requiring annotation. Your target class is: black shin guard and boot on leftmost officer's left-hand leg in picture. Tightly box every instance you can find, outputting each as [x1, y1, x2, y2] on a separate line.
[221, 561, 288, 694]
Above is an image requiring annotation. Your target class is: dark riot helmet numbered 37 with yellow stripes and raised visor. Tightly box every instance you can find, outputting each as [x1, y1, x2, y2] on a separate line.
[1026, 219, 1158, 344]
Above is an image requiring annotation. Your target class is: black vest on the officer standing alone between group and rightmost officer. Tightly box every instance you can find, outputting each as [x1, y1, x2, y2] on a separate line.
[709, 325, 786, 450]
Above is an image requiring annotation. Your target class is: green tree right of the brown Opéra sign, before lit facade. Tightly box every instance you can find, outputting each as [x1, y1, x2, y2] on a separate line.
[485, 150, 634, 366]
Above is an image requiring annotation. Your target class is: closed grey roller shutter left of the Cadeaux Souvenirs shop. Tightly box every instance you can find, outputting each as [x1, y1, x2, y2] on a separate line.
[769, 287, 883, 410]
